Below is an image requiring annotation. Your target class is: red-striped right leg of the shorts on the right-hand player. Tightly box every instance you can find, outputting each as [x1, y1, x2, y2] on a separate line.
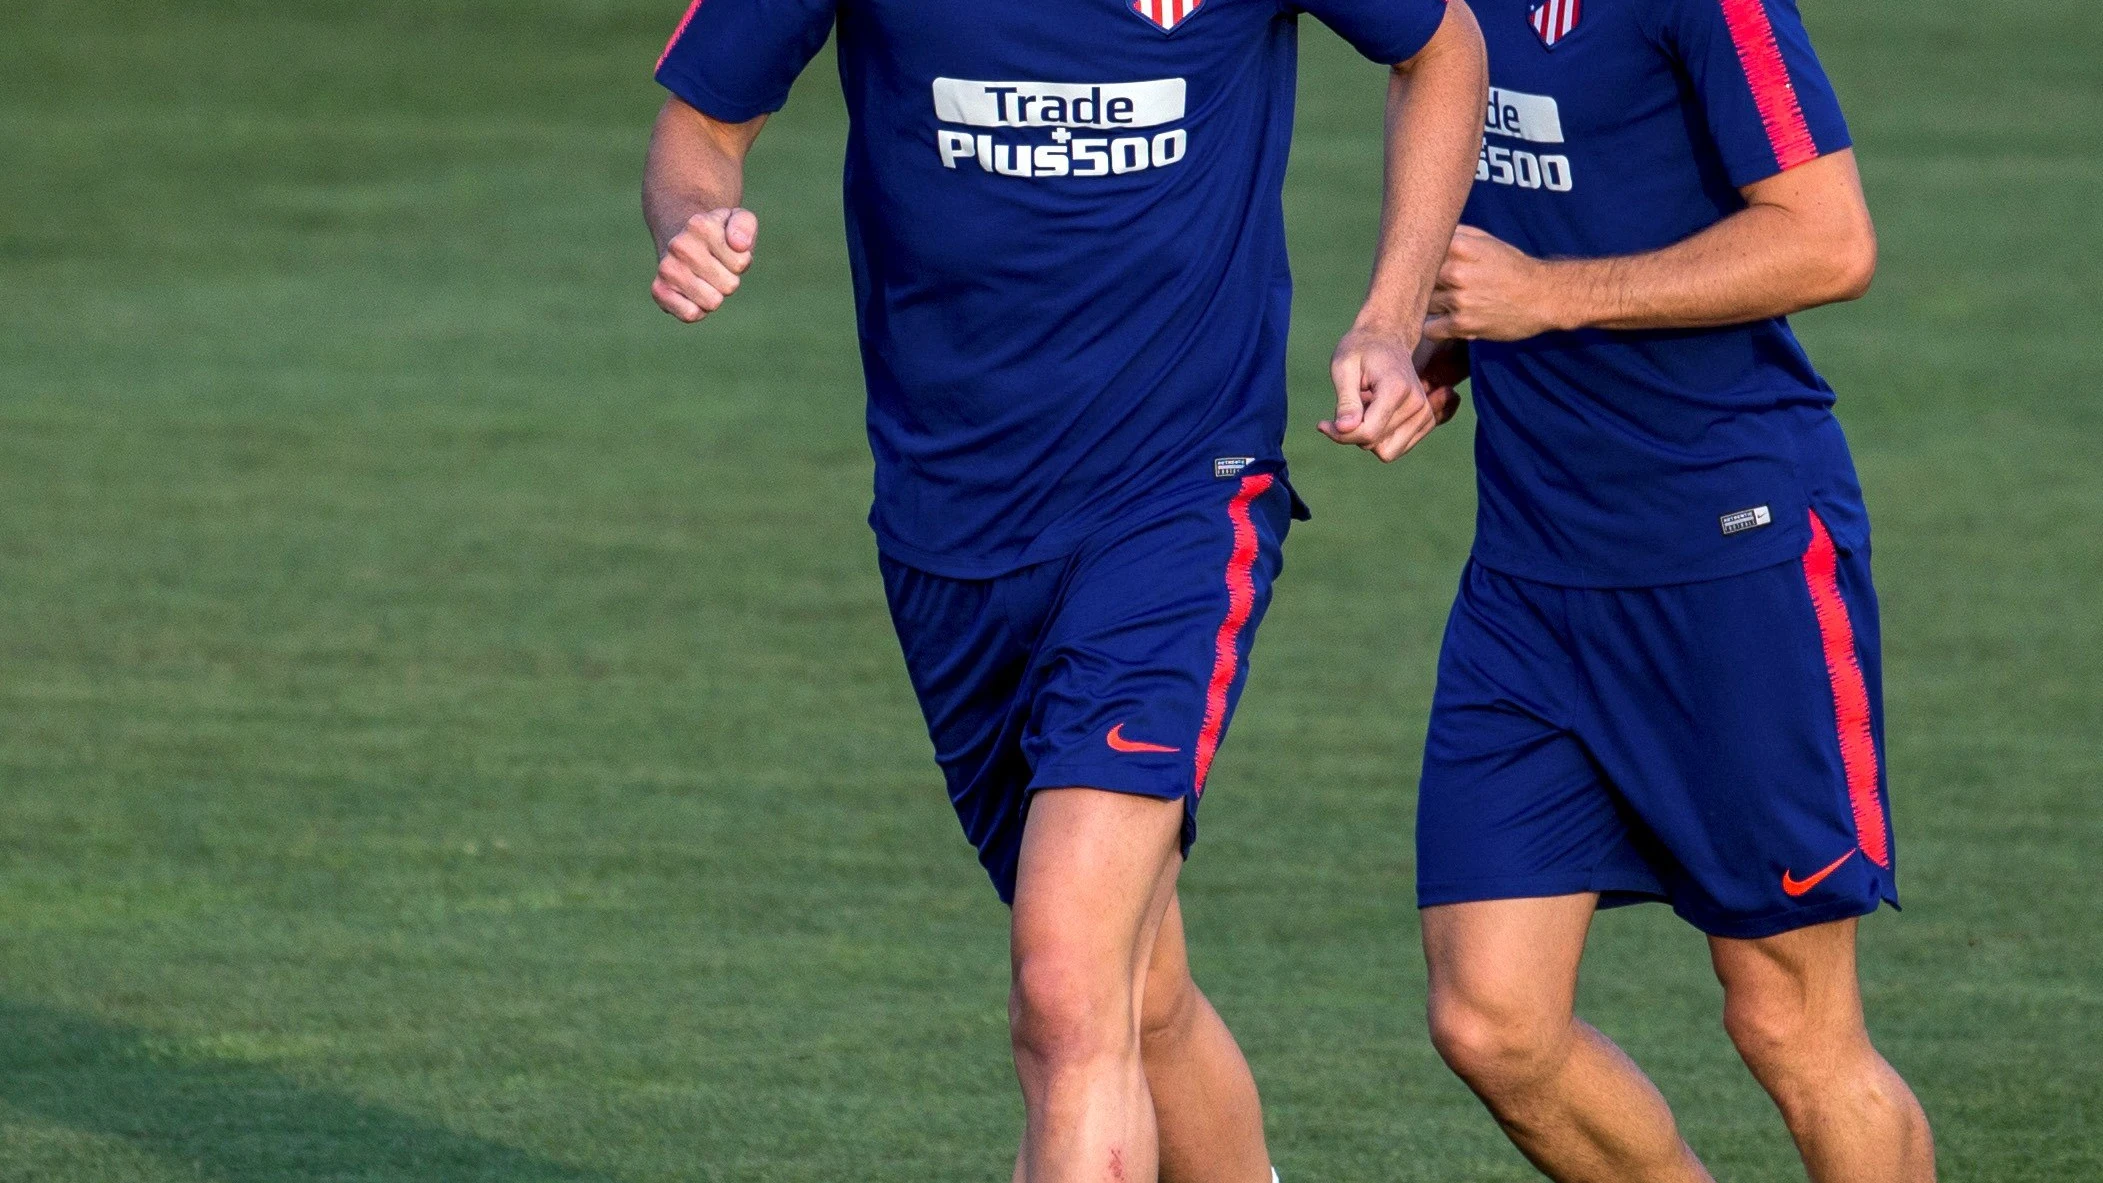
[1577, 514, 1897, 939]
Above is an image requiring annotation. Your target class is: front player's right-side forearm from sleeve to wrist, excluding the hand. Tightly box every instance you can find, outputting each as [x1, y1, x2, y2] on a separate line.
[1359, 0, 1489, 340]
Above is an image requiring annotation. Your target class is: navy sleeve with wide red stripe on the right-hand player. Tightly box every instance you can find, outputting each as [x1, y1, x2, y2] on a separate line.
[1661, 0, 1851, 189]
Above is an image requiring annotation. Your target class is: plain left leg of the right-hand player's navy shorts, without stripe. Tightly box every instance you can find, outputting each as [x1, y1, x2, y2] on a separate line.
[1417, 565, 1659, 908]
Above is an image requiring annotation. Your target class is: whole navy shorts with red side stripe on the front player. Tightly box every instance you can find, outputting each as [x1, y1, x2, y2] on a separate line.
[881, 473, 1304, 904]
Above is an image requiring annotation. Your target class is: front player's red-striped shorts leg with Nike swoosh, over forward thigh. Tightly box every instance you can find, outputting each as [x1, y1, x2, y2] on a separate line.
[1022, 475, 1291, 849]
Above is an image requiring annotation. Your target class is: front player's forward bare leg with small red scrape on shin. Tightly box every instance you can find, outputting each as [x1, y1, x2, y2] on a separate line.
[1007, 788, 1184, 1183]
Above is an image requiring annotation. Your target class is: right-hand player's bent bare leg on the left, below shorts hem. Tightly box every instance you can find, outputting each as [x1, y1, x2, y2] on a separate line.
[1424, 895, 1710, 1183]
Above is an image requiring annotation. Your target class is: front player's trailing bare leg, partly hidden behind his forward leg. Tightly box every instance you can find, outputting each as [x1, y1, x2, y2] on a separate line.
[1140, 893, 1270, 1183]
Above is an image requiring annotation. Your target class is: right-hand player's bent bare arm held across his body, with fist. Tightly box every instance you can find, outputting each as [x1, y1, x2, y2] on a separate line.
[1426, 151, 1876, 340]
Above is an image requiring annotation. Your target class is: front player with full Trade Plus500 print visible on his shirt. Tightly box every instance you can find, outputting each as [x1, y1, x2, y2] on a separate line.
[644, 0, 1485, 1183]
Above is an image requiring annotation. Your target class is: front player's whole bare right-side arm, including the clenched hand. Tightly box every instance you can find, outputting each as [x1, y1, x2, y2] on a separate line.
[1321, 0, 1489, 460]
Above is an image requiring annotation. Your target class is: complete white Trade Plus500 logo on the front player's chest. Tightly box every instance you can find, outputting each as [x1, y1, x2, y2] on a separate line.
[934, 78, 1190, 177]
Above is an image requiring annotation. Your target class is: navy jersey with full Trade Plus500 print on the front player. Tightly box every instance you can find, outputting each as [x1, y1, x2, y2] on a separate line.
[656, 0, 1445, 578]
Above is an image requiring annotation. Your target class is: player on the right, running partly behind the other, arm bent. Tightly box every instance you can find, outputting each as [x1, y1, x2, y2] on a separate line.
[1417, 0, 1935, 1183]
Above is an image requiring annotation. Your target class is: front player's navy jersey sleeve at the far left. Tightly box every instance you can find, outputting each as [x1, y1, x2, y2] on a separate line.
[656, 0, 837, 124]
